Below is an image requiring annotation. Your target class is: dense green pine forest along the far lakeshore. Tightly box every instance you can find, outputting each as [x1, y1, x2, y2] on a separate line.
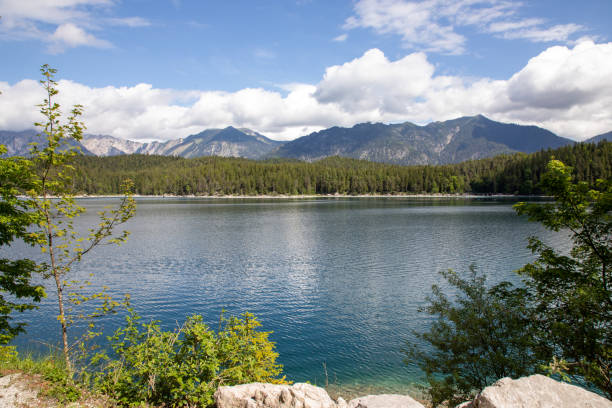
[74, 141, 612, 195]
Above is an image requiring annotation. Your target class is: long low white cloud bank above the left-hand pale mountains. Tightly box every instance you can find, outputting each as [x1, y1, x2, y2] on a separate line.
[0, 80, 351, 140]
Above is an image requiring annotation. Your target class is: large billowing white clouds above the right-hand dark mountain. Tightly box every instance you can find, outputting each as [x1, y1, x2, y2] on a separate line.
[315, 40, 612, 139]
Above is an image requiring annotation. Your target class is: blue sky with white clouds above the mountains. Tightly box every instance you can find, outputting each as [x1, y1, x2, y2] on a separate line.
[0, 0, 612, 141]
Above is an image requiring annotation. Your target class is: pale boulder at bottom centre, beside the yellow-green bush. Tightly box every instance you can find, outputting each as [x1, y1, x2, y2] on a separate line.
[214, 383, 346, 408]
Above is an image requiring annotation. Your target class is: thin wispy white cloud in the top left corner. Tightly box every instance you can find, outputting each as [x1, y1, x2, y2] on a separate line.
[0, 0, 150, 53]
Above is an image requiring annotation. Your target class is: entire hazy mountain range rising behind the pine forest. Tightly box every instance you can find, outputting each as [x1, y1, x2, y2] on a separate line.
[0, 115, 612, 165]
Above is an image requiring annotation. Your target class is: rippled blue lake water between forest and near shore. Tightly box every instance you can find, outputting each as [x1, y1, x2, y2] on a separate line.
[2, 198, 567, 391]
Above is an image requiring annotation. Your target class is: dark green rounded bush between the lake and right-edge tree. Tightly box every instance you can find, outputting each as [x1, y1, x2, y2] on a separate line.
[406, 266, 542, 407]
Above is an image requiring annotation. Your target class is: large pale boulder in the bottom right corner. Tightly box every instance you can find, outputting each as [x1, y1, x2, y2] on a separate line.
[459, 374, 612, 408]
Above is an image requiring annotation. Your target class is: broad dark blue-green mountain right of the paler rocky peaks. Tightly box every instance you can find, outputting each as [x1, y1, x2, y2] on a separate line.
[271, 115, 571, 164]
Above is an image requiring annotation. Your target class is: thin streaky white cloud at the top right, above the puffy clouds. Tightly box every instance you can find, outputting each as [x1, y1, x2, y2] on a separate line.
[344, 0, 583, 54]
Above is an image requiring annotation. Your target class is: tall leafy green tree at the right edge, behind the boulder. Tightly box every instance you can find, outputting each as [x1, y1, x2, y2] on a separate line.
[515, 160, 612, 399]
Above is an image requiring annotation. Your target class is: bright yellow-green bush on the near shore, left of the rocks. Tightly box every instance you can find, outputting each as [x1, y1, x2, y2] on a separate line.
[94, 311, 285, 407]
